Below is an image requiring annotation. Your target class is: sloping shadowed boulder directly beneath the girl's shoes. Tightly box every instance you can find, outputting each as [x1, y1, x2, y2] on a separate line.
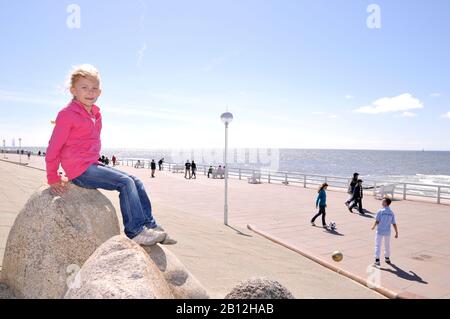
[143, 245, 209, 299]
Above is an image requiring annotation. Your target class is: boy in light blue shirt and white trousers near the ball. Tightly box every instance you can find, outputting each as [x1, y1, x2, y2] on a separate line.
[372, 198, 398, 266]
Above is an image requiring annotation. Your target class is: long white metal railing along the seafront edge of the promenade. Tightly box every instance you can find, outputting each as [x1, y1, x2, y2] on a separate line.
[118, 159, 450, 204]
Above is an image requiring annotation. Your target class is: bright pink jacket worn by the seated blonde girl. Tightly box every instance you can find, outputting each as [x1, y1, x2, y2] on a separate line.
[45, 100, 102, 184]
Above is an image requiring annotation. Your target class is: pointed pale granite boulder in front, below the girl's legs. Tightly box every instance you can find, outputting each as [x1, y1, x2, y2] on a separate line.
[65, 236, 174, 299]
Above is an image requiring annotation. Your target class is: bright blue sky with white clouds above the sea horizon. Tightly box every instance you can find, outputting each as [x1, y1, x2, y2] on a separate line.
[0, 0, 450, 150]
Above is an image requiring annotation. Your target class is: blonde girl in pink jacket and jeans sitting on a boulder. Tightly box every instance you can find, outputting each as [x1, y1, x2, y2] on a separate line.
[45, 65, 176, 245]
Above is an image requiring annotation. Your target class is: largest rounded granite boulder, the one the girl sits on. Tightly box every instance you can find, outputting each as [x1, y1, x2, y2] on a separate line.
[2, 184, 120, 298]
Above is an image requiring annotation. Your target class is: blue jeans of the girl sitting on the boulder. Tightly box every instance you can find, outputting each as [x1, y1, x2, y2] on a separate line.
[72, 164, 157, 238]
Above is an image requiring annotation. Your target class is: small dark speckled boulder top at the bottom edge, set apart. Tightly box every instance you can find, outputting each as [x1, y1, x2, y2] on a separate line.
[225, 278, 294, 299]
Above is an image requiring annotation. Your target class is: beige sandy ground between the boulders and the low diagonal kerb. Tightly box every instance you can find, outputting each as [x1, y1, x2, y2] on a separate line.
[0, 156, 383, 298]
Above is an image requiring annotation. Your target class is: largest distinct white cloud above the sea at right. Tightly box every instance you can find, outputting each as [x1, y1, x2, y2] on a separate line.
[355, 93, 424, 114]
